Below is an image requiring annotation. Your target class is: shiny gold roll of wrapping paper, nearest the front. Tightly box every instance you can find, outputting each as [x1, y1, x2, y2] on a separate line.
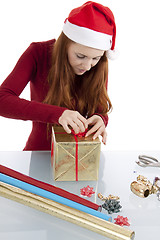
[0, 182, 135, 240]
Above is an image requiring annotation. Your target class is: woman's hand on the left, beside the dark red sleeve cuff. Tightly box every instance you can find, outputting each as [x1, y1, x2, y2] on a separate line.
[58, 110, 87, 134]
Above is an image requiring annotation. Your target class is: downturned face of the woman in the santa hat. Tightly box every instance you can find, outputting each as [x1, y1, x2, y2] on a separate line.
[68, 43, 104, 75]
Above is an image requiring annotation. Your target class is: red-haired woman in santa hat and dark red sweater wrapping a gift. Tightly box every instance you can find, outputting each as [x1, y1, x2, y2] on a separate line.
[0, 1, 116, 151]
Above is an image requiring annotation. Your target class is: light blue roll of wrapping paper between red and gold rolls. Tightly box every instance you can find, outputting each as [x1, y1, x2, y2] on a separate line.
[0, 173, 111, 221]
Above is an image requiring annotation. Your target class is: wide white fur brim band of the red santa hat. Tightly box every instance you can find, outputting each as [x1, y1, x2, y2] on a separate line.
[63, 19, 112, 51]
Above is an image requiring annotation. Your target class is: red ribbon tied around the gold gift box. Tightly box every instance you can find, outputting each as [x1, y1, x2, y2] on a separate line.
[55, 129, 88, 181]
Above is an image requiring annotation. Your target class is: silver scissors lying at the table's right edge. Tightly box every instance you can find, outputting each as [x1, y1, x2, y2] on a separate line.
[136, 155, 160, 167]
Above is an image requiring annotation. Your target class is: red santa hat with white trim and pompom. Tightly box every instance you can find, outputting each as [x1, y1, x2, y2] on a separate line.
[63, 1, 116, 59]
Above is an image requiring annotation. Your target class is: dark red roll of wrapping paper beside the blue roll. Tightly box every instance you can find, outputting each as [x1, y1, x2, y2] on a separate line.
[0, 165, 101, 210]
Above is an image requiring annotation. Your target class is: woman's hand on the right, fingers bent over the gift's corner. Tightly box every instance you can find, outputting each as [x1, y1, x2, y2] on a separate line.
[86, 115, 107, 145]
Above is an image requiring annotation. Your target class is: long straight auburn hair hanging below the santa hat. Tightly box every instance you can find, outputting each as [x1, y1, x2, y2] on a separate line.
[45, 32, 112, 117]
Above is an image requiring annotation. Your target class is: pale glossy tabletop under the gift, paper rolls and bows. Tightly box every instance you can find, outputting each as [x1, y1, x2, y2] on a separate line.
[0, 151, 160, 240]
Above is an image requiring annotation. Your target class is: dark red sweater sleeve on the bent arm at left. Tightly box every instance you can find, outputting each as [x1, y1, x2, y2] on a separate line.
[0, 44, 66, 123]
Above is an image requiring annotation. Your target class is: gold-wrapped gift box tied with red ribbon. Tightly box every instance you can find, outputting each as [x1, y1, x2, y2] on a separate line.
[51, 126, 101, 181]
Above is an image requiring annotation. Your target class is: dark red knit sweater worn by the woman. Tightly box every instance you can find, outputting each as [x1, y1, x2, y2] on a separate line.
[0, 40, 108, 151]
